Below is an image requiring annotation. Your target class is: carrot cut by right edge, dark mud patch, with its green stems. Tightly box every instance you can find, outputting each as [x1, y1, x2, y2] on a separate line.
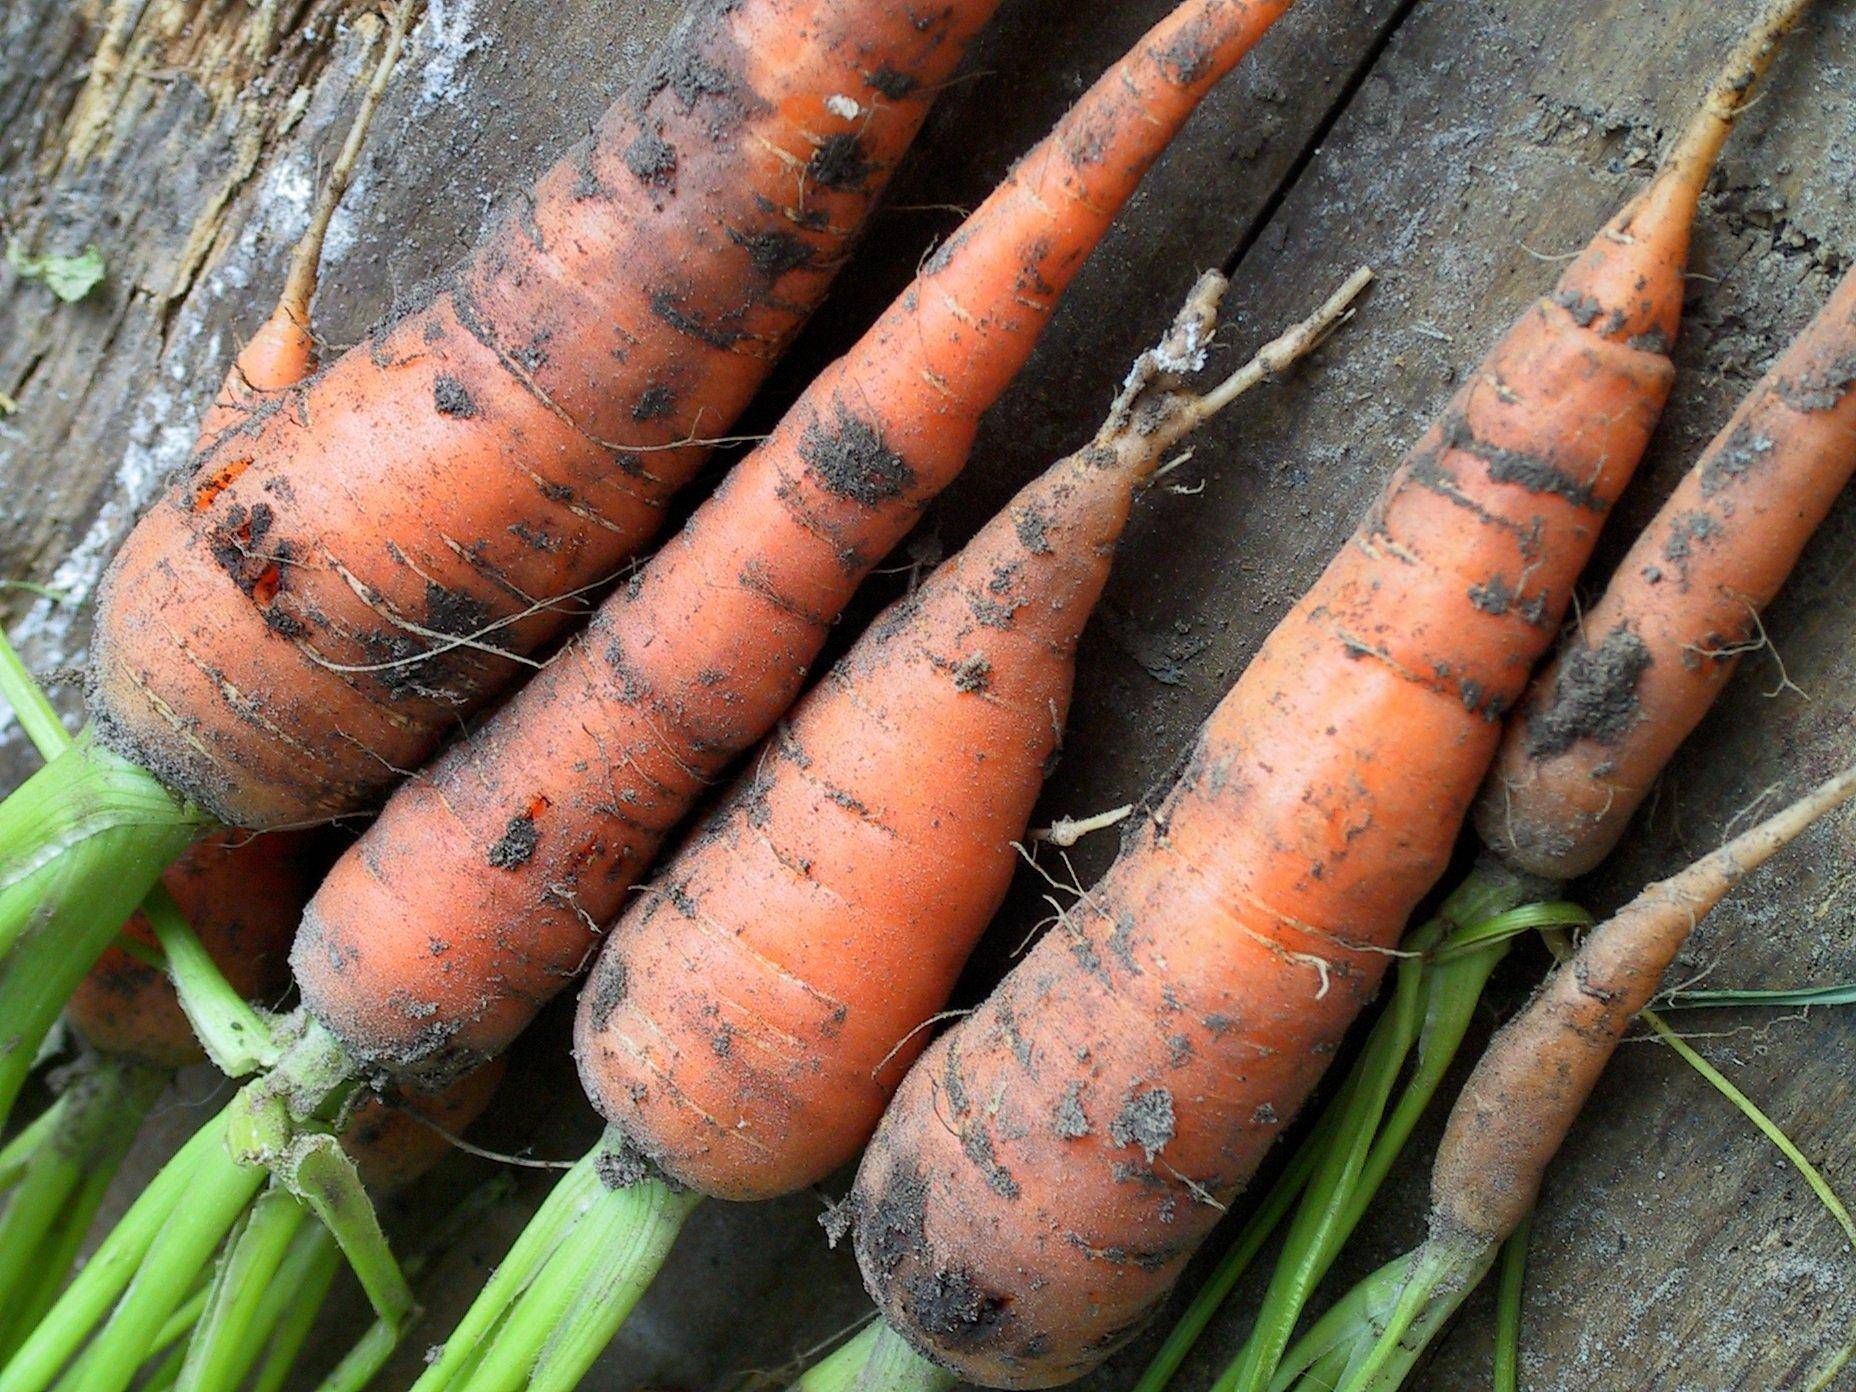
[1136, 261, 1856, 1392]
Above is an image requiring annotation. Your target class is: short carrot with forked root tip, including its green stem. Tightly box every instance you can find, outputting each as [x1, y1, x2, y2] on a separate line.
[399, 261, 1370, 1392]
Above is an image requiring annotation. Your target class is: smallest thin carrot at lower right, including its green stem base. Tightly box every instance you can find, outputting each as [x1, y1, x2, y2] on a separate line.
[1288, 768, 1856, 1392]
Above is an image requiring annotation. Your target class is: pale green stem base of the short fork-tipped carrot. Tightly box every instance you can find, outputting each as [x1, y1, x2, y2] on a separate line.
[489, 1179, 702, 1392]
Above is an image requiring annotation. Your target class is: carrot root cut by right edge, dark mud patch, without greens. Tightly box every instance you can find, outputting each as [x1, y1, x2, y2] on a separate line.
[1476, 275, 1856, 880]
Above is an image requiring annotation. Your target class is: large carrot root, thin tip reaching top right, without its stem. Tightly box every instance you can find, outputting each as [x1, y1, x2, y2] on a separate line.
[856, 0, 1802, 1386]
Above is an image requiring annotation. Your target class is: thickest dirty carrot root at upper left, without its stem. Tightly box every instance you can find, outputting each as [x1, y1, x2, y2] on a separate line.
[93, 0, 997, 826]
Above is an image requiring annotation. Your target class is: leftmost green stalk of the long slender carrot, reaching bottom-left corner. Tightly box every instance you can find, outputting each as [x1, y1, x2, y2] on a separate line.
[0, 1112, 225, 1392]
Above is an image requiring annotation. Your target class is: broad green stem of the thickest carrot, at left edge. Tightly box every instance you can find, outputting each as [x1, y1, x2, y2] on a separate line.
[0, 731, 208, 1123]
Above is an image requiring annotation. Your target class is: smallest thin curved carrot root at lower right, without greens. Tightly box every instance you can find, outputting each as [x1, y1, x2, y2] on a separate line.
[1431, 770, 1856, 1247]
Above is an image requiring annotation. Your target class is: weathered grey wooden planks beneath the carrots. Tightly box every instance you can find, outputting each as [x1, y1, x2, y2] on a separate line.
[0, 0, 1856, 1392]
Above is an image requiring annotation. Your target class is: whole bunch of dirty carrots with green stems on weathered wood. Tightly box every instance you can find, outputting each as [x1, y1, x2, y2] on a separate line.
[0, 0, 1856, 1392]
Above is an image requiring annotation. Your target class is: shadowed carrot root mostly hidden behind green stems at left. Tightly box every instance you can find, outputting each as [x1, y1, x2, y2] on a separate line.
[65, 831, 316, 1069]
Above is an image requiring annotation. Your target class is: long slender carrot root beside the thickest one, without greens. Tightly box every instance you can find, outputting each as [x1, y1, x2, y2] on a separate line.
[293, 0, 1286, 1071]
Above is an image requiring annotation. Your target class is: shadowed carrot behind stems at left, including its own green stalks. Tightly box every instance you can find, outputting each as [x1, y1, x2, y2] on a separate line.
[0, 833, 310, 1359]
